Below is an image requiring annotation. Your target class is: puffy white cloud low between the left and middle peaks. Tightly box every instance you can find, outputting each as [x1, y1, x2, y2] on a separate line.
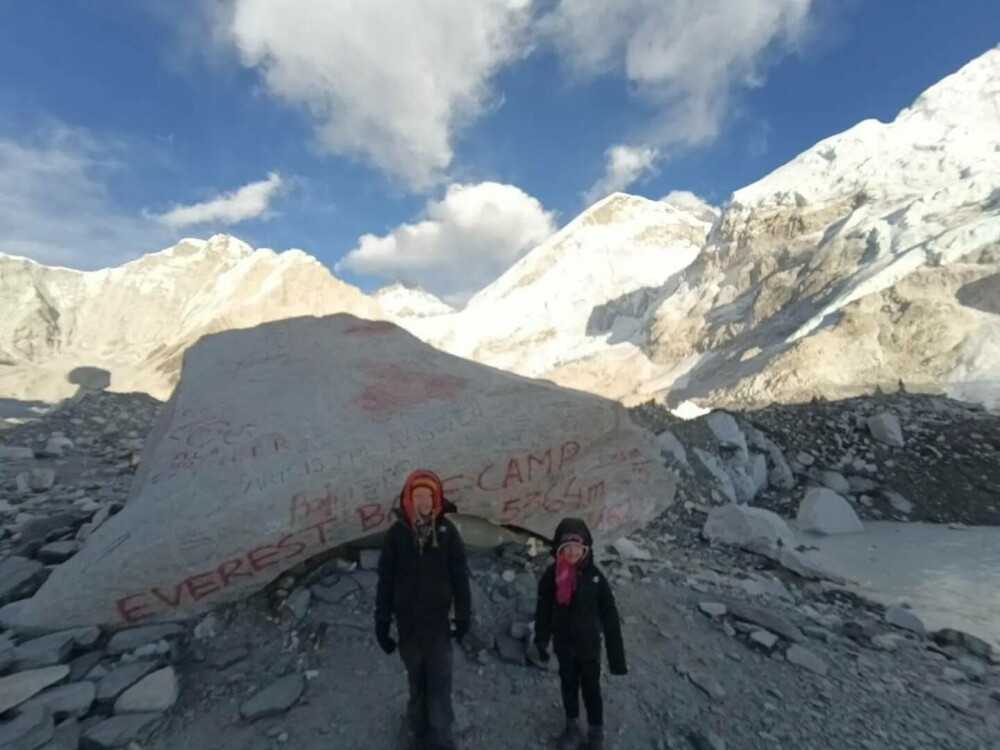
[336, 182, 555, 302]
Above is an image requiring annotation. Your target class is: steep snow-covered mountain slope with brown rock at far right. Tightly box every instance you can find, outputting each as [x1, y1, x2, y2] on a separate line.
[645, 47, 1000, 412]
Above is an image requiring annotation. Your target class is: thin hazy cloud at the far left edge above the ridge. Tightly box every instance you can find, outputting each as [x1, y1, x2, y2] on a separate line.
[0, 126, 171, 269]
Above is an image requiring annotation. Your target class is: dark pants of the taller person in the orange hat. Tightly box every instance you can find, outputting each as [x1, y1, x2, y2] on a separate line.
[399, 630, 455, 750]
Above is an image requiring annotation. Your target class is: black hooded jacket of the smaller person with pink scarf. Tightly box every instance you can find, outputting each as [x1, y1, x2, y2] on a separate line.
[535, 518, 626, 671]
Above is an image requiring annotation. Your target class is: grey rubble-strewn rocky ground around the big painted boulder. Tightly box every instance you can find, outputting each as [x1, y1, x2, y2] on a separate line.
[0, 394, 1000, 750]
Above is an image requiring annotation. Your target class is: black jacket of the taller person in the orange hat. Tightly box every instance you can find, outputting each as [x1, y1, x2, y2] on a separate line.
[375, 500, 470, 633]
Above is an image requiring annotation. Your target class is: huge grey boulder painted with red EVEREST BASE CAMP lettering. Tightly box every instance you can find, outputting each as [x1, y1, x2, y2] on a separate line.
[8, 315, 675, 628]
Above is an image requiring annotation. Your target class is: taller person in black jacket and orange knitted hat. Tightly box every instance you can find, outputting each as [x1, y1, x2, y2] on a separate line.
[375, 470, 471, 750]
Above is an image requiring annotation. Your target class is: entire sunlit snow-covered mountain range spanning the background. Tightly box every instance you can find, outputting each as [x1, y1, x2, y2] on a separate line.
[0, 47, 1000, 406]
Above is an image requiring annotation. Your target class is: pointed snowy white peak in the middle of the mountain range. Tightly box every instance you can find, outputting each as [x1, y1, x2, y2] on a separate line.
[400, 193, 711, 396]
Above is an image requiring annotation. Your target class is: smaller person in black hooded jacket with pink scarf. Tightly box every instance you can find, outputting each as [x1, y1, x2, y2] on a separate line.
[534, 518, 628, 750]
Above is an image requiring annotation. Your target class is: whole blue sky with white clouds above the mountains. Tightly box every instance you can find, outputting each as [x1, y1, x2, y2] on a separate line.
[0, 0, 1000, 299]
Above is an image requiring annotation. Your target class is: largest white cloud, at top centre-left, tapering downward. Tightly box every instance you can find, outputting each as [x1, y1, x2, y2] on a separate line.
[219, 0, 531, 189]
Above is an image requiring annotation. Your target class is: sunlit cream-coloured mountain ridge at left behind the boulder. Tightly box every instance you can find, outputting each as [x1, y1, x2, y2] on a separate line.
[0, 235, 384, 401]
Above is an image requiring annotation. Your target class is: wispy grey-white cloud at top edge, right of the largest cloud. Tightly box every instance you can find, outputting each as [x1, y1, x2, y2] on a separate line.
[544, 0, 814, 189]
